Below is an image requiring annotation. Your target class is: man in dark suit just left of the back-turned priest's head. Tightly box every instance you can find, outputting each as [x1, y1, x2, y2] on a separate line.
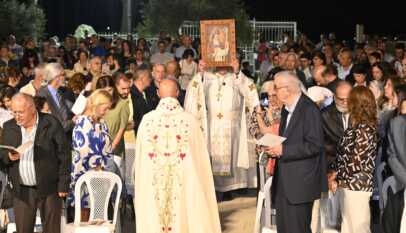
[130, 69, 154, 136]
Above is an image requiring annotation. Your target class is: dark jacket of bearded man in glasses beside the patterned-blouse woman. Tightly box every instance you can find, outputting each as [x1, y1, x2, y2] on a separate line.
[321, 103, 344, 168]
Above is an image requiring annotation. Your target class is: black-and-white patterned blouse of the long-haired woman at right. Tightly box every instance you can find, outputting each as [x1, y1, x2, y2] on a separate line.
[336, 124, 378, 192]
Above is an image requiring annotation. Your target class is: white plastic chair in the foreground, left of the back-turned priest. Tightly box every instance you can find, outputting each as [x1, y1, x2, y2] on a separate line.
[64, 171, 122, 233]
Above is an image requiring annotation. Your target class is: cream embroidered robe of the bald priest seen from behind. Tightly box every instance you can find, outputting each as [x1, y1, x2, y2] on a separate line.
[134, 98, 221, 233]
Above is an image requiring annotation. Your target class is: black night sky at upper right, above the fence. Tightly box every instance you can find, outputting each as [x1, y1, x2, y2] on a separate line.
[244, 0, 406, 39]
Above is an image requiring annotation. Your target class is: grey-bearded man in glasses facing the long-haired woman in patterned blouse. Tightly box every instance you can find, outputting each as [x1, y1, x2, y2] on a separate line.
[321, 81, 352, 168]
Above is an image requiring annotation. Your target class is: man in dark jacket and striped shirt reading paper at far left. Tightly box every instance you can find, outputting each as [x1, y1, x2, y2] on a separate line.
[0, 94, 71, 233]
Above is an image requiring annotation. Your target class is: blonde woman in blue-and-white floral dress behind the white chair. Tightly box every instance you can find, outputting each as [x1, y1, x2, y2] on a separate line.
[68, 90, 112, 220]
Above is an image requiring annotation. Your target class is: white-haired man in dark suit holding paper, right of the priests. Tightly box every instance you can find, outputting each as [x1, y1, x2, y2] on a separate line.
[267, 71, 327, 233]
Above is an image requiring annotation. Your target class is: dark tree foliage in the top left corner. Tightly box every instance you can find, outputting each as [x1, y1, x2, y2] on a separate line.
[0, 0, 46, 38]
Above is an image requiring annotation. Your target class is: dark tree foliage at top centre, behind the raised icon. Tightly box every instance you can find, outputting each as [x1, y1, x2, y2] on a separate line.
[137, 0, 252, 44]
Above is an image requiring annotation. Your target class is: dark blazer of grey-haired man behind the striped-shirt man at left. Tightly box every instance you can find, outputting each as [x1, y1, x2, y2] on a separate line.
[38, 86, 74, 134]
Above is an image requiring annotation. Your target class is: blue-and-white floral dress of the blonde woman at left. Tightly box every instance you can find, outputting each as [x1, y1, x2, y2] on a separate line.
[68, 116, 112, 208]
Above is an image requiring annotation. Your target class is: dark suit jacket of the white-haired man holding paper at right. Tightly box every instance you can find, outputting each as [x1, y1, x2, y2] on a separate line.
[272, 94, 327, 204]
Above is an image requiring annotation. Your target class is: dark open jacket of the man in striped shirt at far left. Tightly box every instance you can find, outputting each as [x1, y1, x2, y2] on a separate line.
[0, 113, 72, 198]
